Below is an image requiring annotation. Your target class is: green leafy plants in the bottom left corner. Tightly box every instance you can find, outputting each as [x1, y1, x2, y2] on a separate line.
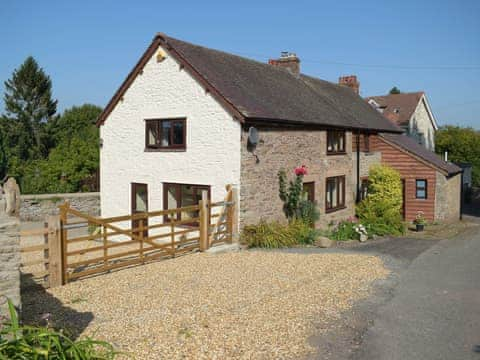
[0, 300, 118, 360]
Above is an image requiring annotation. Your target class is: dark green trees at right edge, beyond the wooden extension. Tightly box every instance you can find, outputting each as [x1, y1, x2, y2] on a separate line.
[435, 125, 480, 186]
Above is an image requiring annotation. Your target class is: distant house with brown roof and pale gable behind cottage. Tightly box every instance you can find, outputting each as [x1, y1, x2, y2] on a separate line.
[366, 91, 438, 151]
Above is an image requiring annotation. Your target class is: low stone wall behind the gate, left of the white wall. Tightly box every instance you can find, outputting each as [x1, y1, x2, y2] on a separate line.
[20, 192, 100, 221]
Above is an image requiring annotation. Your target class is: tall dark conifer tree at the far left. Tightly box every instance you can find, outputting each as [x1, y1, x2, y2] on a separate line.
[4, 56, 57, 163]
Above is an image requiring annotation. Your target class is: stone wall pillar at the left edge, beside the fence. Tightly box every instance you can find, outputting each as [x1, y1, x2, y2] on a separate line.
[0, 216, 20, 315]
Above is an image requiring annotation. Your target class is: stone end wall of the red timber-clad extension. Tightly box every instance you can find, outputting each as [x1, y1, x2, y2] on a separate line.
[435, 171, 462, 222]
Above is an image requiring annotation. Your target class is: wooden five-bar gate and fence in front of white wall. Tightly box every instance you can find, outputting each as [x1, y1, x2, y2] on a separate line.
[20, 186, 238, 287]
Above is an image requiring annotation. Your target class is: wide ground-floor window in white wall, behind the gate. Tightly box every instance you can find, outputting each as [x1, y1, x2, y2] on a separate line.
[163, 183, 210, 224]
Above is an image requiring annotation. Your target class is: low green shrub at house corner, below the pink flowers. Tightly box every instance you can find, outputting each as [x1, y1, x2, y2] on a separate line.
[241, 220, 317, 249]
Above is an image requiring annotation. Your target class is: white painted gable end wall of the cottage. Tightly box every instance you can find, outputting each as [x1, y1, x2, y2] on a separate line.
[100, 44, 241, 222]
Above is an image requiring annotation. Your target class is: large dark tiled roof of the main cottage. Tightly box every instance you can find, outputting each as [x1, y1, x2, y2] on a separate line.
[97, 34, 401, 132]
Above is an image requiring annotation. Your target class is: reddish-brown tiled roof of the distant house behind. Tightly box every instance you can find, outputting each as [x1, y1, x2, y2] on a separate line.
[366, 91, 424, 126]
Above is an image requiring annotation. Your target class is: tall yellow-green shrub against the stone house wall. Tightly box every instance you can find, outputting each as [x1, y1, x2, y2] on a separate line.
[356, 165, 405, 235]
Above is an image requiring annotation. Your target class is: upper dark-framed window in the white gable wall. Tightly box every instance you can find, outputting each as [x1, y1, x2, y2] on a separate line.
[145, 119, 186, 150]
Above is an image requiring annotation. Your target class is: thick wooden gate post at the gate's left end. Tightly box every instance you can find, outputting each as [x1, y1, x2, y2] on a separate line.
[48, 215, 64, 287]
